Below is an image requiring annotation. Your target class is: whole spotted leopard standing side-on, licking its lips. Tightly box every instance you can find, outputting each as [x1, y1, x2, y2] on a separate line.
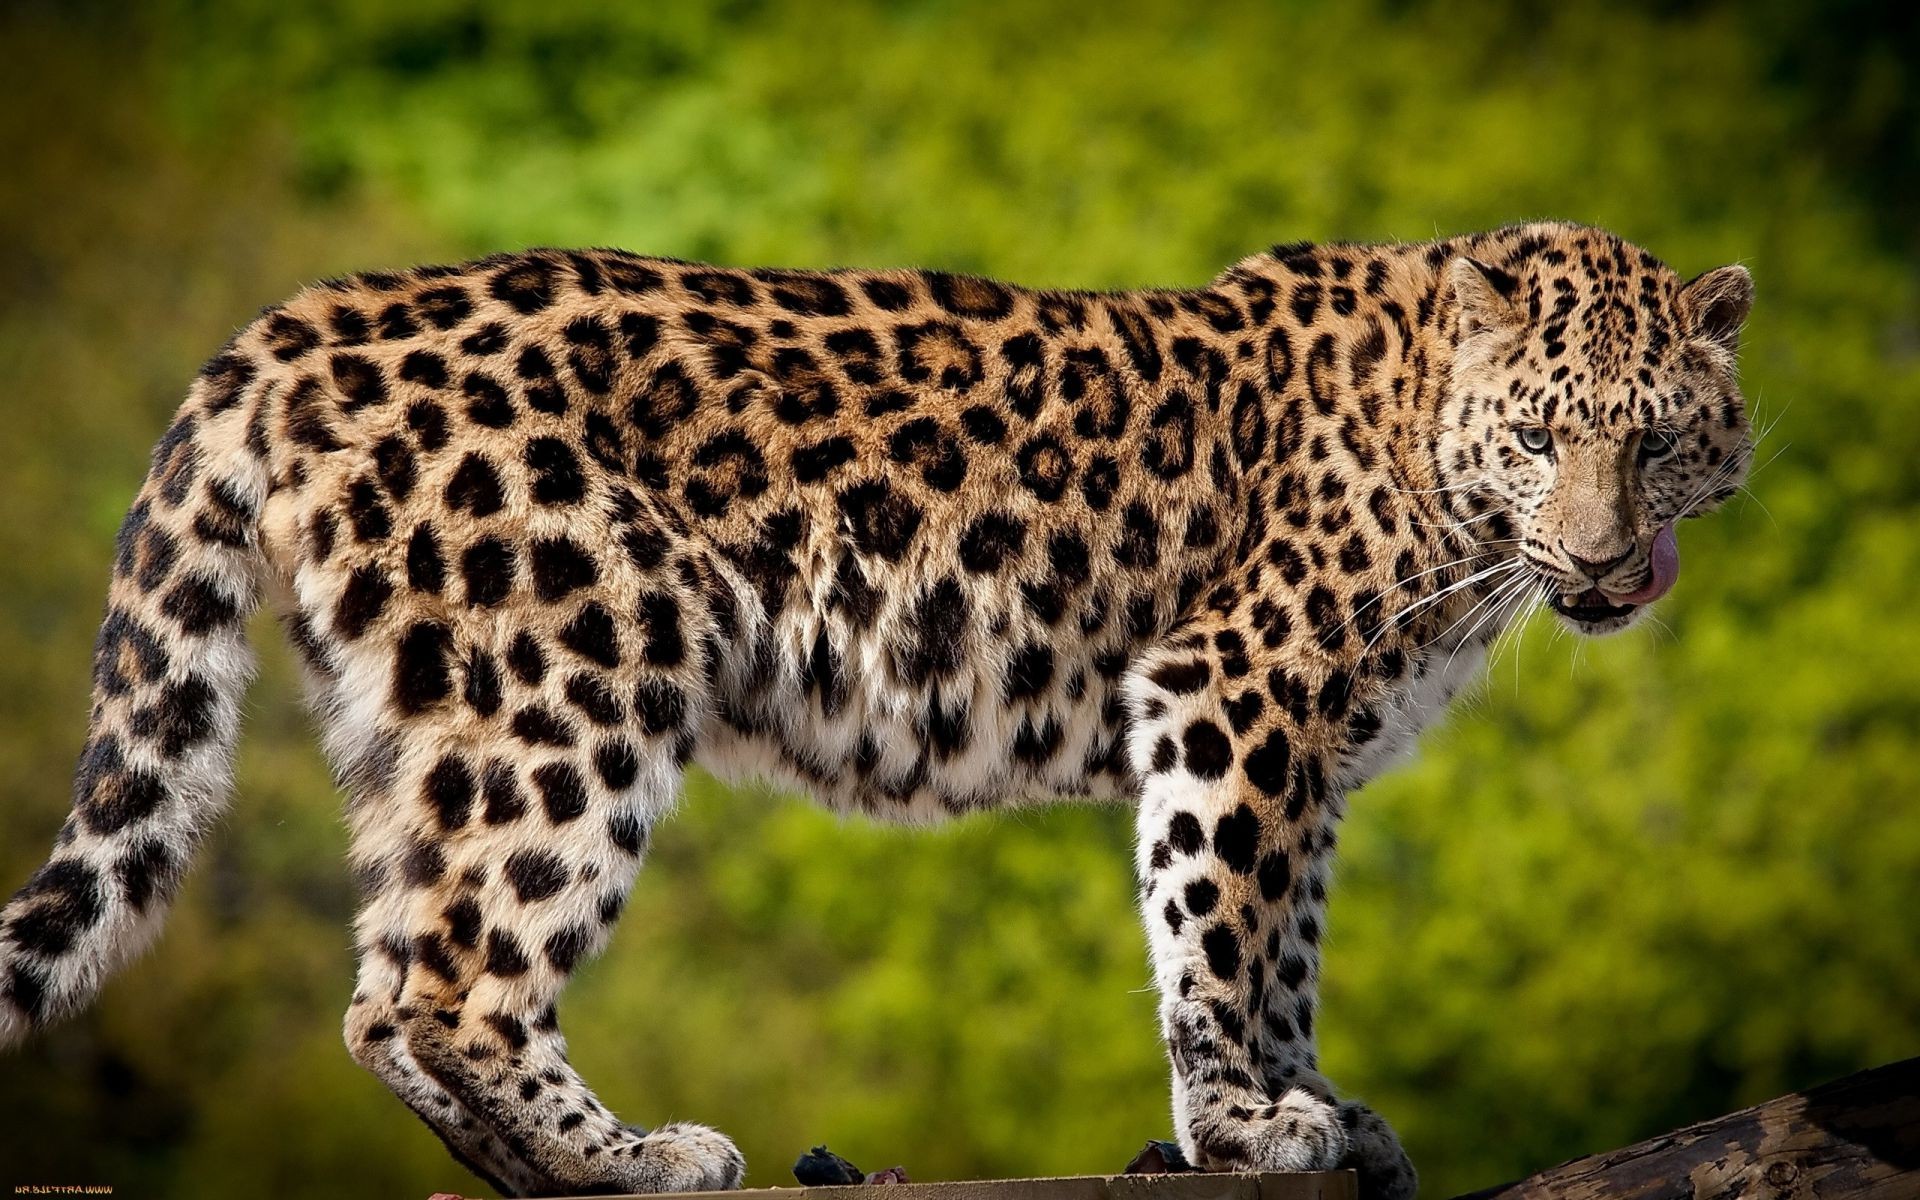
[0, 221, 1755, 1200]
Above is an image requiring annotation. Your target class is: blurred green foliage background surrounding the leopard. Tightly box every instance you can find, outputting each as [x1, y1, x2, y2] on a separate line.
[0, 0, 1920, 1200]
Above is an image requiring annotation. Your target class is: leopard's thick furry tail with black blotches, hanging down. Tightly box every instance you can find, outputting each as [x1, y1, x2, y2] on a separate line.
[0, 349, 267, 1046]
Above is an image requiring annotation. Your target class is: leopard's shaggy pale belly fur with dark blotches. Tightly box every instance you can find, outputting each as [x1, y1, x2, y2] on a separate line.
[693, 538, 1136, 822]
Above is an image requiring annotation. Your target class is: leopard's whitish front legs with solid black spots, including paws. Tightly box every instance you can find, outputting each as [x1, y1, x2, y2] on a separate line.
[1129, 630, 1415, 1200]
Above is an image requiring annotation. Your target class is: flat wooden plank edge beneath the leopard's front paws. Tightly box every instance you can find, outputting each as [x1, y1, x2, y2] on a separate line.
[545, 1171, 1359, 1200]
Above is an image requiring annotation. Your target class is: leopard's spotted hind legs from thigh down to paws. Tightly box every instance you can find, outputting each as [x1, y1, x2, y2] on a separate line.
[299, 529, 745, 1194]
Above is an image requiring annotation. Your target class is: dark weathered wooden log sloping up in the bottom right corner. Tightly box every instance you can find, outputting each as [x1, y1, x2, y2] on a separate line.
[1457, 1058, 1920, 1200]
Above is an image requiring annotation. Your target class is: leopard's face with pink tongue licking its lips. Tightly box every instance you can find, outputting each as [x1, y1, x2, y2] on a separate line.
[1440, 244, 1753, 636]
